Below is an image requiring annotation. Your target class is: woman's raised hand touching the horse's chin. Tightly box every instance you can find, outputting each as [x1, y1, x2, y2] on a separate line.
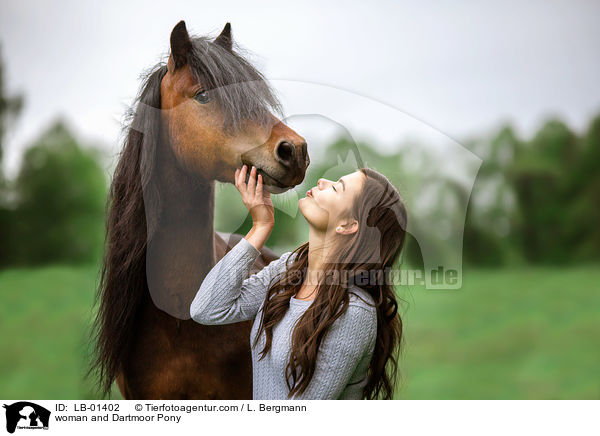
[235, 165, 275, 228]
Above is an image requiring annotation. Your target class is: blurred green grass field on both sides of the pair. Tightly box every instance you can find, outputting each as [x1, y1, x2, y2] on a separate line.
[0, 266, 600, 399]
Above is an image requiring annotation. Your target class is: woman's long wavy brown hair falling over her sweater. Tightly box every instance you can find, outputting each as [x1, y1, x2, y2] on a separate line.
[254, 168, 407, 399]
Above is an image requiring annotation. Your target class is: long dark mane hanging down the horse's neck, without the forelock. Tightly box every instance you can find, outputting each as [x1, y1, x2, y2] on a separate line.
[86, 65, 167, 396]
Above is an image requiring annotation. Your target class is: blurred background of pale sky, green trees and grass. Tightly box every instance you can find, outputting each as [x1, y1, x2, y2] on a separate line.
[0, 1, 600, 399]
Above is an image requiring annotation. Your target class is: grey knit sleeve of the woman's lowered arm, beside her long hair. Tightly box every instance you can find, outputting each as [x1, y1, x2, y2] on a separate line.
[291, 305, 377, 400]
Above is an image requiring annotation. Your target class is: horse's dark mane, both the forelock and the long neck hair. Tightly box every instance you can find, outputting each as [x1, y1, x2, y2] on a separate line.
[85, 32, 281, 397]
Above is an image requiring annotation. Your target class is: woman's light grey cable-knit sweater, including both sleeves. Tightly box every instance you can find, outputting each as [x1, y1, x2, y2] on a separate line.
[190, 238, 377, 400]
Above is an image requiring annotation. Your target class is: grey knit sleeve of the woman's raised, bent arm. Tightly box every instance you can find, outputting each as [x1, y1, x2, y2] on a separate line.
[190, 238, 291, 325]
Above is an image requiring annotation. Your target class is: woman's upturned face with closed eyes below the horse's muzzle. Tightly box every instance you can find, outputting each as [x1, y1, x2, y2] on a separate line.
[298, 171, 366, 233]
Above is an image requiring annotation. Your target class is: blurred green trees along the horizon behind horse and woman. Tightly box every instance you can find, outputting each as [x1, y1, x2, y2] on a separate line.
[0, 49, 600, 267]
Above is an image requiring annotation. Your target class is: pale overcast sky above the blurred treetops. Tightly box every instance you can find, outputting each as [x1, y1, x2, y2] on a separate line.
[0, 0, 600, 172]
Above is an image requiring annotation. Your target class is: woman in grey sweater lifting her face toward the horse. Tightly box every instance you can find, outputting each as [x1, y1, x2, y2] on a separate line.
[190, 165, 406, 400]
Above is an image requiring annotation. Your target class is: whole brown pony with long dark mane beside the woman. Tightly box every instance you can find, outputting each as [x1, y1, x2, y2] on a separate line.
[86, 21, 310, 400]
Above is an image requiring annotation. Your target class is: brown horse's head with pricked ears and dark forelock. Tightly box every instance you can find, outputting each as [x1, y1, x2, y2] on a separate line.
[161, 21, 310, 193]
